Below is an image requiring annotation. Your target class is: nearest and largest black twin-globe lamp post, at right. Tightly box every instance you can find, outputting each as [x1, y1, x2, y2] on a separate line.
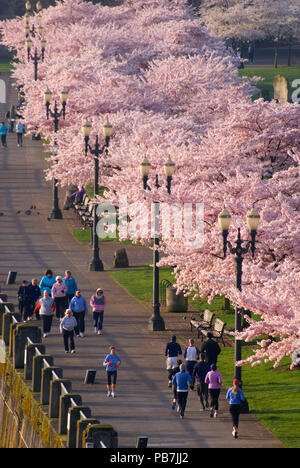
[218, 208, 260, 382]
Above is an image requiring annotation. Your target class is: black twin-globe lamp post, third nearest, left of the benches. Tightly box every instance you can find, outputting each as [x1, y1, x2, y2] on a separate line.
[82, 121, 112, 271]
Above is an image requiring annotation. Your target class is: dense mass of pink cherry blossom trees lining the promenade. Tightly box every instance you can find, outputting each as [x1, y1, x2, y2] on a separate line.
[2, 0, 300, 363]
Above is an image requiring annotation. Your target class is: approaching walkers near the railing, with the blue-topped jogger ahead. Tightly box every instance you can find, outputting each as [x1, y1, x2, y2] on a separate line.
[18, 269, 121, 398]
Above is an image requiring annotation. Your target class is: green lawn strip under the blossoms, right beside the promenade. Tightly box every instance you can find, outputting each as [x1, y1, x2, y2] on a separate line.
[108, 265, 300, 448]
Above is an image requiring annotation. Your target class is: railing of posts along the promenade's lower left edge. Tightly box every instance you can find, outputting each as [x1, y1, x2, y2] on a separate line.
[0, 298, 118, 448]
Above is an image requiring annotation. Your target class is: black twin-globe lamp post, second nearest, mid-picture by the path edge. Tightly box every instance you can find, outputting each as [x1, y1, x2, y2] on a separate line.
[139, 158, 175, 331]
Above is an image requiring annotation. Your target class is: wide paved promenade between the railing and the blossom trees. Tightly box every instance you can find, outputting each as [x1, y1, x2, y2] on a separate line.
[0, 75, 282, 448]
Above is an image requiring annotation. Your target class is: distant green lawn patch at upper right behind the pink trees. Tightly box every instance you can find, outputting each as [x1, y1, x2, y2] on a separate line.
[239, 66, 300, 99]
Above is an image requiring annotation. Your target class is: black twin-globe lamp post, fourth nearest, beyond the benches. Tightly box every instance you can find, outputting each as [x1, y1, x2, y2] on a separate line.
[44, 89, 68, 219]
